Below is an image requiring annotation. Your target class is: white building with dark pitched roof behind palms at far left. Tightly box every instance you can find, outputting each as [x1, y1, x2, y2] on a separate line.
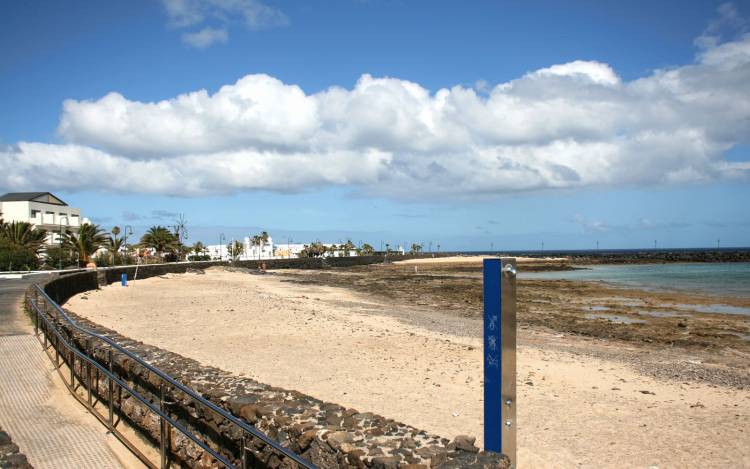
[0, 192, 90, 244]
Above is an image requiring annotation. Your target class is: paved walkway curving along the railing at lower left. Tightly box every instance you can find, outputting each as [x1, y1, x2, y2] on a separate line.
[0, 276, 130, 469]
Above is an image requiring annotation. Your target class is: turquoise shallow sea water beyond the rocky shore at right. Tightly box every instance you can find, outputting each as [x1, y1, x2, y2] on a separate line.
[519, 262, 750, 298]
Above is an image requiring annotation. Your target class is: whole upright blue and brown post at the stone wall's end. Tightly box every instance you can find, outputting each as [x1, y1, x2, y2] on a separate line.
[483, 258, 516, 467]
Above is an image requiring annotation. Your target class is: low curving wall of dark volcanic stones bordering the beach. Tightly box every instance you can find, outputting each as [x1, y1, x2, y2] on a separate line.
[30, 266, 509, 469]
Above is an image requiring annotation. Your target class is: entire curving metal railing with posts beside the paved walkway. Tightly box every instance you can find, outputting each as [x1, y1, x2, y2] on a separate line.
[26, 284, 315, 469]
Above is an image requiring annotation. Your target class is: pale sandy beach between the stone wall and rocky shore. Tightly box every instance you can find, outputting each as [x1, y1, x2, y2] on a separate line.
[66, 263, 750, 468]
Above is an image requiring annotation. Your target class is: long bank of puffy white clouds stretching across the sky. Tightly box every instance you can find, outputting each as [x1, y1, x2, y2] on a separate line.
[0, 16, 750, 199]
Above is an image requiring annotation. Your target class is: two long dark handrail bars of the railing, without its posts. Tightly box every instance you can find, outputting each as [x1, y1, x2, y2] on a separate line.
[32, 284, 317, 469]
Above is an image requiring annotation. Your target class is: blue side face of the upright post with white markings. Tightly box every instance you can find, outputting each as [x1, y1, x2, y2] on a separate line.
[484, 259, 503, 453]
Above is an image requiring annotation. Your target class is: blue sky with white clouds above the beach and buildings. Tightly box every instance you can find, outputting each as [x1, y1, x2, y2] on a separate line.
[0, 0, 750, 250]
